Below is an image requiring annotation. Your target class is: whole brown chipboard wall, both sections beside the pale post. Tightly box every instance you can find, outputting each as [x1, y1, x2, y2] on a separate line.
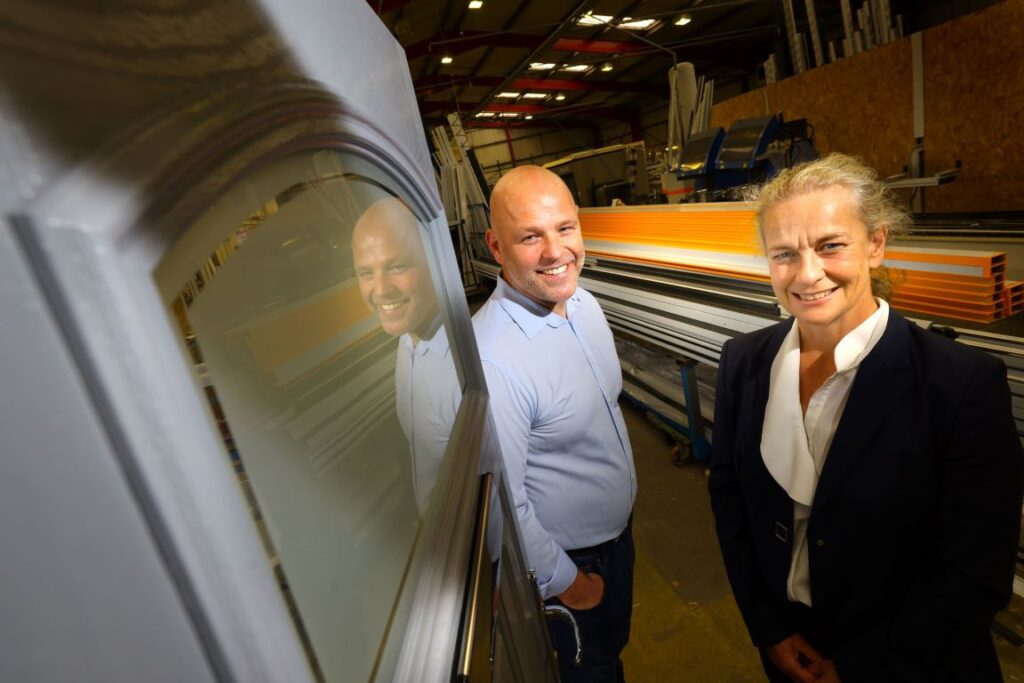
[712, 0, 1024, 212]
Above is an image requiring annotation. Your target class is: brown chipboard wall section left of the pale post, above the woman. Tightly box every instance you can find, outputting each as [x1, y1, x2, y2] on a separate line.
[712, 39, 913, 175]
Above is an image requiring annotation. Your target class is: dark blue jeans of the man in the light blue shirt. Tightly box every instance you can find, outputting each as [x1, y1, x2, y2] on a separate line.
[548, 520, 635, 683]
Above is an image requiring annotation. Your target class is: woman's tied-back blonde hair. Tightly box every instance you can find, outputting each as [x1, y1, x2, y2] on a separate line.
[746, 153, 911, 299]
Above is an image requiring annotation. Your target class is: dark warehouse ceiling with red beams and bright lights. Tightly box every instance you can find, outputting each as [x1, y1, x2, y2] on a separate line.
[368, 0, 992, 127]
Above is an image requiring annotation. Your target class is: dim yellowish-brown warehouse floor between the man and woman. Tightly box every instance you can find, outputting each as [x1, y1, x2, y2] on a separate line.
[623, 403, 1024, 683]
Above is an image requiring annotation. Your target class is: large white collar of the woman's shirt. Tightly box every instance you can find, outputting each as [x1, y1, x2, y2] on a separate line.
[761, 299, 889, 506]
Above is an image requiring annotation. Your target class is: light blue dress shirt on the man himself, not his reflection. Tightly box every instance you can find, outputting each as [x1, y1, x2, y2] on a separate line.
[473, 279, 636, 598]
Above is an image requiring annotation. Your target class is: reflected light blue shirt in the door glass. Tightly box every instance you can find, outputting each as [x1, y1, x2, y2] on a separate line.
[394, 325, 462, 513]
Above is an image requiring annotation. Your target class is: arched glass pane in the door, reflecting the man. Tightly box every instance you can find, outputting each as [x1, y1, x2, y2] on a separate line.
[158, 152, 461, 682]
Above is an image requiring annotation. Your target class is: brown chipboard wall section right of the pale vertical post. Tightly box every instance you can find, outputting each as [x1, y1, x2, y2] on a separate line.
[925, 0, 1024, 212]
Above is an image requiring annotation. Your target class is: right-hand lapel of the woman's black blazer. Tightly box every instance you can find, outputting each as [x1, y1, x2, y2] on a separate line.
[812, 309, 912, 514]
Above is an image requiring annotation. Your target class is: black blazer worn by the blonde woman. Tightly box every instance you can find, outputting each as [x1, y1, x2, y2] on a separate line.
[710, 310, 1024, 683]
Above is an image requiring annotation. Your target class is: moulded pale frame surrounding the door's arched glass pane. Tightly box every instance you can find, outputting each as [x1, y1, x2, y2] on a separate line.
[11, 82, 486, 683]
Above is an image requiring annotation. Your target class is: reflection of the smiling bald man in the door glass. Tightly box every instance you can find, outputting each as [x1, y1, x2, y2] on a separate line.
[352, 197, 461, 511]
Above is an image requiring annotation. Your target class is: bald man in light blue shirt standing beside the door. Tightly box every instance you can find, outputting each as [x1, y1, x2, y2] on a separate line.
[473, 166, 636, 683]
